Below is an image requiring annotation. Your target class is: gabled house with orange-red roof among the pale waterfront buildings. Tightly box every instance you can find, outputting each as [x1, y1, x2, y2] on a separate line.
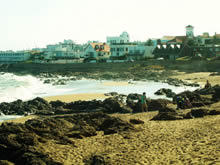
[84, 42, 111, 60]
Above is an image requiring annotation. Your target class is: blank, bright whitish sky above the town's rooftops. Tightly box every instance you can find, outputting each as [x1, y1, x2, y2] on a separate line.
[0, 0, 220, 51]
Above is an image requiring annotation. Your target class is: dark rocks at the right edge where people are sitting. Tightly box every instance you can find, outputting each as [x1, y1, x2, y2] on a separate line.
[151, 85, 220, 120]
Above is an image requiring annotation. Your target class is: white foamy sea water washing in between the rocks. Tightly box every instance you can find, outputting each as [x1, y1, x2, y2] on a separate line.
[0, 72, 197, 121]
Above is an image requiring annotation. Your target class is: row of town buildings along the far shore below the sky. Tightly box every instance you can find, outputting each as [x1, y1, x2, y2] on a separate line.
[0, 25, 220, 64]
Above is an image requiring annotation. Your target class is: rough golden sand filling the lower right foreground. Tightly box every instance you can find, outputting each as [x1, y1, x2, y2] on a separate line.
[39, 112, 220, 165]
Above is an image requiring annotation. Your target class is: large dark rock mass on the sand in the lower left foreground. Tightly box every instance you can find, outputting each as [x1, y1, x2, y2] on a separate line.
[0, 113, 135, 165]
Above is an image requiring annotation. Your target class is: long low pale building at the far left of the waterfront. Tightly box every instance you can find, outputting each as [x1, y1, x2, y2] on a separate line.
[0, 51, 30, 62]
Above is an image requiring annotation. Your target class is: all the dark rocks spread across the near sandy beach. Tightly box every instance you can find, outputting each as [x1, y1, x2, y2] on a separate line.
[0, 85, 220, 164]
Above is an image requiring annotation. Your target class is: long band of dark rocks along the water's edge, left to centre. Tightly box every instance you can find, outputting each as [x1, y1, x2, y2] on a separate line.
[0, 94, 170, 115]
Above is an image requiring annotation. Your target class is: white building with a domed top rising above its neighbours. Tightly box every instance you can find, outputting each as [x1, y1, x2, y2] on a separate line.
[107, 32, 130, 45]
